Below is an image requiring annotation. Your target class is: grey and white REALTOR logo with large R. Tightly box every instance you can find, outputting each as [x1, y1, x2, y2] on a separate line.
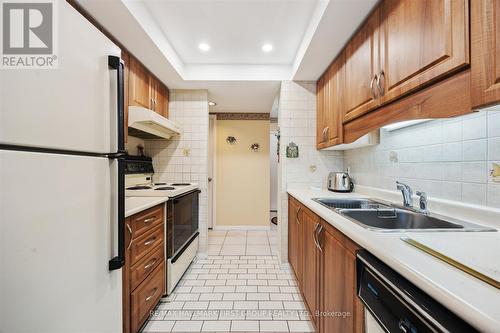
[0, 0, 57, 69]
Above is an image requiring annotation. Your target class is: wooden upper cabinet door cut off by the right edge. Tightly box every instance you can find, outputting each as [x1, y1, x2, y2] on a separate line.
[470, 0, 500, 108]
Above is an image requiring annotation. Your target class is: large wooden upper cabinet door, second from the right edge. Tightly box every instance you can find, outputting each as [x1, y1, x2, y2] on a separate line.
[377, 0, 470, 104]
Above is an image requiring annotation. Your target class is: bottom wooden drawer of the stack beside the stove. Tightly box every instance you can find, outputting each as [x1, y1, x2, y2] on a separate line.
[130, 262, 165, 332]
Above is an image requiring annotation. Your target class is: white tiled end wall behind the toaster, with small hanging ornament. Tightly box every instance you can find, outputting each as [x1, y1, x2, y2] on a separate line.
[278, 81, 344, 262]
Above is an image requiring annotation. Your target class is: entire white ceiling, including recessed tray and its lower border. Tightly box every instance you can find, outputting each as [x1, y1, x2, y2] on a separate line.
[77, 0, 377, 112]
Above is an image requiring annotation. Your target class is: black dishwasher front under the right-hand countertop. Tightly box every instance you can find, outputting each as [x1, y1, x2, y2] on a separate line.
[357, 250, 478, 333]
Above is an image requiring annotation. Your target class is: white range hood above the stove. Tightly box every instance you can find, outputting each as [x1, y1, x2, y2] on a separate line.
[128, 105, 181, 139]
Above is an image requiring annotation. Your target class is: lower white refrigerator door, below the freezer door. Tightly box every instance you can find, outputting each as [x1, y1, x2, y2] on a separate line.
[0, 150, 122, 333]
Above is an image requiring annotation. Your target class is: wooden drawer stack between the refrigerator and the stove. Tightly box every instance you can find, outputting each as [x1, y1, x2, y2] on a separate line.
[122, 204, 167, 333]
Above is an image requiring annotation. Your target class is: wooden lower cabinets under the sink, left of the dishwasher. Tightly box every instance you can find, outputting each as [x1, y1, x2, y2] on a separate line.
[288, 196, 364, 333]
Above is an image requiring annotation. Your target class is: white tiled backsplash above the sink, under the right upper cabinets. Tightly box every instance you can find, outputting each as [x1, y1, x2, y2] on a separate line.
[344, 106, 500, 208]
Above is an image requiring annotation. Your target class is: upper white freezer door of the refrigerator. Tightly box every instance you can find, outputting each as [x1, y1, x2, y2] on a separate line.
[0, 1, 121, 153]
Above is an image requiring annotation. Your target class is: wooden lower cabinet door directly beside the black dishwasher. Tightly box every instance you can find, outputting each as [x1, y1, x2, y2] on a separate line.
[318, 222, 364, 333]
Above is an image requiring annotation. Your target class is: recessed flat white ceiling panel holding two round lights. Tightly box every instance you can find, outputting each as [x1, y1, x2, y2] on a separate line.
[144, 0, 319, 65]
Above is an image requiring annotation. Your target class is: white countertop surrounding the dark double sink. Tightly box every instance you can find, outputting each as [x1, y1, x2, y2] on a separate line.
[288, 188, 500, 332]
